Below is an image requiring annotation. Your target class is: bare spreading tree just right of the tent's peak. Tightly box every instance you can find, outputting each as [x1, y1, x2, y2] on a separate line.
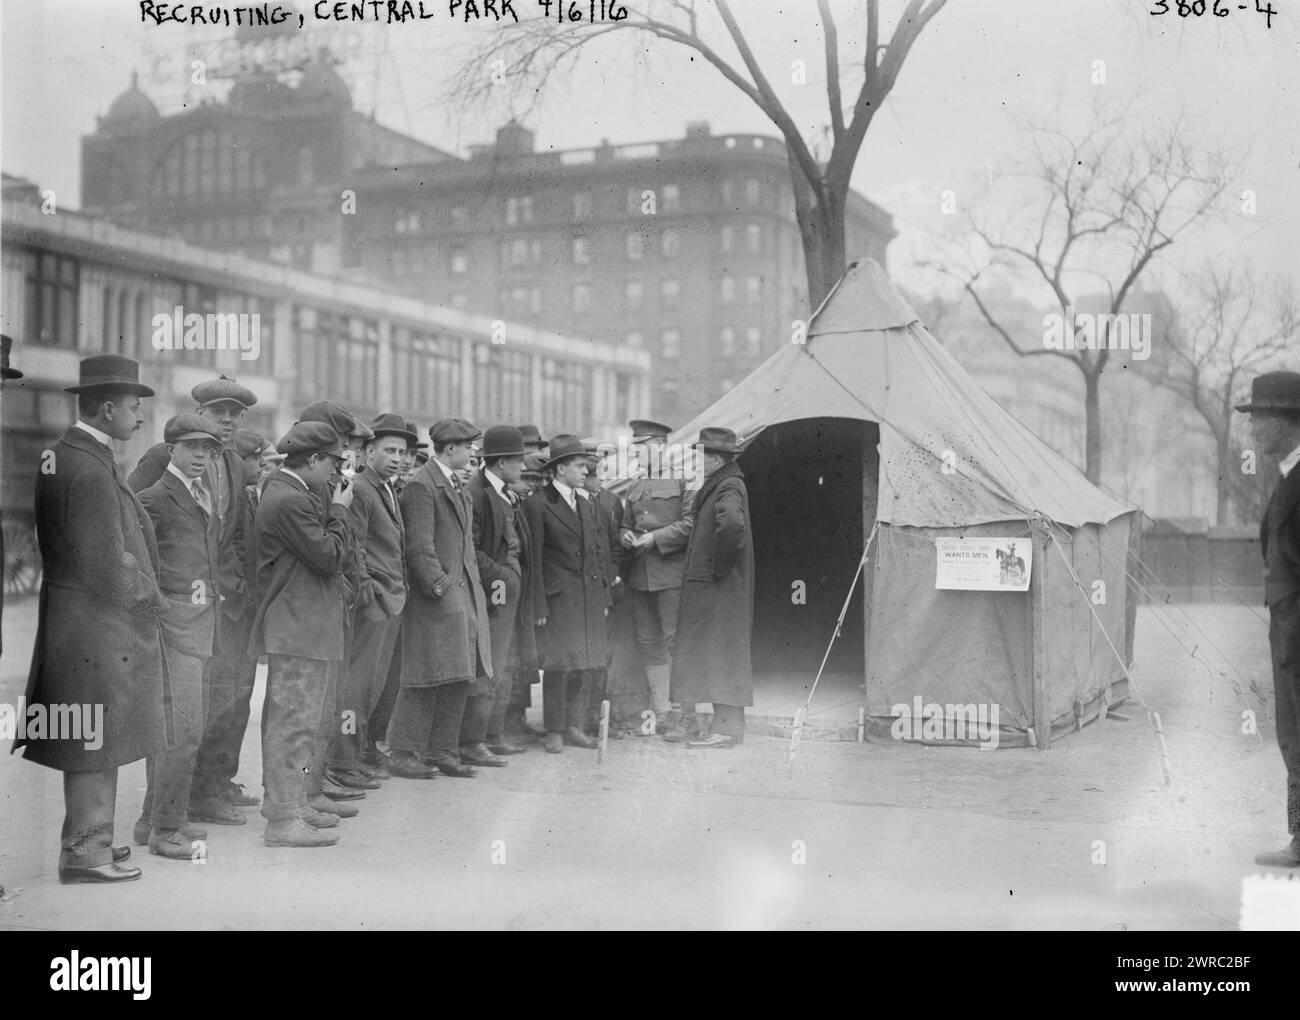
[936, 103, 1227, 482]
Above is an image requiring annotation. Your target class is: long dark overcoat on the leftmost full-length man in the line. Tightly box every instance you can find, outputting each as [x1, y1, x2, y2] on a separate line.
[13, 426, 172, 772]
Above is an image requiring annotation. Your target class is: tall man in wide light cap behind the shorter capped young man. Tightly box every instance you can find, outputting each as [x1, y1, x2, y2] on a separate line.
[127, 376, 257, 825]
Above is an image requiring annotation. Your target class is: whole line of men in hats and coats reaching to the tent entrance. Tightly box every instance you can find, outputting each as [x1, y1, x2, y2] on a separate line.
[16, 355, 753, 882]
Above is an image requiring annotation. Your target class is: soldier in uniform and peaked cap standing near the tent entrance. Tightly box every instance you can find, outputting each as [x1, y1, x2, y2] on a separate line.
[620, 418, 696, 741]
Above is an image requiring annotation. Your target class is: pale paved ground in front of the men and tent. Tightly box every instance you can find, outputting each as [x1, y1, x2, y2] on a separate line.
[0, 603, 1300, 930]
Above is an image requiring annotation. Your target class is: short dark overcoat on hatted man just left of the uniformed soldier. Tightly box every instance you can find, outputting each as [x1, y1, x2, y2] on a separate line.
[524, 482, 611, 670]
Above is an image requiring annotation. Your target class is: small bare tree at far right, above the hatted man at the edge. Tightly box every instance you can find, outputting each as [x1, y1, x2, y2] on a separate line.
[1157, 264, 1300, 525]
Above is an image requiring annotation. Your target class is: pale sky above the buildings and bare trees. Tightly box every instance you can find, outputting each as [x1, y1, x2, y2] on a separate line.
[0, 0, 1300, 302]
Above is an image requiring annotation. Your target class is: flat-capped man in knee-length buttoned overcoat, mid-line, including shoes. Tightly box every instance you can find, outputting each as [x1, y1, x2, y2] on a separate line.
[389, 418, 493, 780]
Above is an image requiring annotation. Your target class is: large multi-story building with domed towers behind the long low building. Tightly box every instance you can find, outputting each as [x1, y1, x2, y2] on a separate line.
[82, 60, 894, 424]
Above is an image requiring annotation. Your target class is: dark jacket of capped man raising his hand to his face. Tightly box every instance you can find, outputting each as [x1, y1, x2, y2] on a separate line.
[248, 469, 354, 663]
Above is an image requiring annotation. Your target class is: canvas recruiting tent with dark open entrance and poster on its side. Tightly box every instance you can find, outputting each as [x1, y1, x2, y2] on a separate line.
[613, 261, 1135, 746]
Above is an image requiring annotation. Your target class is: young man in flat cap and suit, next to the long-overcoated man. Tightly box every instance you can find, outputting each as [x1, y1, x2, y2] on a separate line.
[134, 414, 221, 860]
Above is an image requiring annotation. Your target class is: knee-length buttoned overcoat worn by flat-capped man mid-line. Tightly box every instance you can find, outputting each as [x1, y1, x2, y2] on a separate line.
[402, 459, 491, 687]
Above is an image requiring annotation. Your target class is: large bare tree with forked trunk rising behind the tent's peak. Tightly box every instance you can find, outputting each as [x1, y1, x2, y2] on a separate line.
[451, 0, 948, 308]
